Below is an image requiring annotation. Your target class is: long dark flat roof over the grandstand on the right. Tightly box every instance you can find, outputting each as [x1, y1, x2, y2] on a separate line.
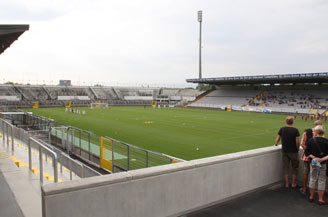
[187, 72, 328, 85]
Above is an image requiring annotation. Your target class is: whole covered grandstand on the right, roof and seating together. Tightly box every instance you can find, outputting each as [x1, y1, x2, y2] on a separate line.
[187, 73, 328, 114]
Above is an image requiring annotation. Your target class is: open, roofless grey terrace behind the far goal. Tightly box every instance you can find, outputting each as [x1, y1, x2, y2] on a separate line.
[0, 85, 202, 107]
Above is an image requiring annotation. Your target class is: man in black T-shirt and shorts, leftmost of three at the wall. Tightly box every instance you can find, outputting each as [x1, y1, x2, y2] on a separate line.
[275, 116, 300, 188]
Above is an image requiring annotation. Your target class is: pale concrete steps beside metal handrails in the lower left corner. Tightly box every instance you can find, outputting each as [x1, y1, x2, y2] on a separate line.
[0, 135, 79, 217]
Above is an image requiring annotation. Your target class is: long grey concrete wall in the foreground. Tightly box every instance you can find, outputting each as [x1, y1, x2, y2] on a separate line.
[42, 147, 282, 217]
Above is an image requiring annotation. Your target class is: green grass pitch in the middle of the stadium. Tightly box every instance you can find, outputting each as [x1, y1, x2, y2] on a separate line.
[26, 106, 327, 160]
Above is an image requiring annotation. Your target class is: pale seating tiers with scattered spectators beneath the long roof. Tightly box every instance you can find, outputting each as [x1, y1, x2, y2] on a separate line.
[189, 85, 328, 113]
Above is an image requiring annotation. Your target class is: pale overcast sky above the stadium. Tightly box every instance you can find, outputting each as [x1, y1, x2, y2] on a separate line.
[0, 0, 328, 87]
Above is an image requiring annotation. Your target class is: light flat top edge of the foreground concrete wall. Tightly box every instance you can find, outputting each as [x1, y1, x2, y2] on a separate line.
[41, 145, 281, 196]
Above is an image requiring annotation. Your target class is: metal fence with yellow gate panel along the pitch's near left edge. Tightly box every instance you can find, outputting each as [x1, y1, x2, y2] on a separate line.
[1, 113, 183, 172]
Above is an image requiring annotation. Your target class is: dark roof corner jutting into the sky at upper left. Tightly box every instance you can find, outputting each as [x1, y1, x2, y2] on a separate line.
[0, 25, 30, 54]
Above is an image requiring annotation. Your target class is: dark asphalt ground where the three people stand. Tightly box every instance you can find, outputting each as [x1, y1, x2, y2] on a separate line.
[184, 187, 328, 217]
